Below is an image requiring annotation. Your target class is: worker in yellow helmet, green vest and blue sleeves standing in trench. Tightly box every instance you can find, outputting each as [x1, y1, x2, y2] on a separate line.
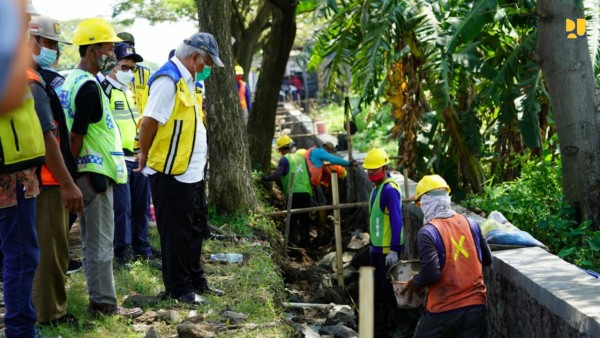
[363, 148, 404, 337]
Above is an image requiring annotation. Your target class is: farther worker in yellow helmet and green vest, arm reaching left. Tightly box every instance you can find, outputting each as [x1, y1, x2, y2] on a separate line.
[261, 135, 312, 247]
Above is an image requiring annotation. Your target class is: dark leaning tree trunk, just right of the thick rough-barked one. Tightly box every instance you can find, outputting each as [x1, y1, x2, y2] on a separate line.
[248, 0, 296, 172]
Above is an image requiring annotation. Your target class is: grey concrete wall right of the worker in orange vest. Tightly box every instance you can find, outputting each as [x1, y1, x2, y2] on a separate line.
[485, 248, 600, 338]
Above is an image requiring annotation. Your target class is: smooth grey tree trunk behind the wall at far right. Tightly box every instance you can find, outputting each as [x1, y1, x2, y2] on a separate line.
[537, 0, 600, 227]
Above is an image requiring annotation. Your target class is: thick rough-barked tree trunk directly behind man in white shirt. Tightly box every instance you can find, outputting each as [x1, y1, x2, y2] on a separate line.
[197, 0, 257, 214]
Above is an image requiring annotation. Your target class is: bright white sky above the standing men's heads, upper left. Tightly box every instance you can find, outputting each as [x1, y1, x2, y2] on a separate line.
[33, 0, 197, 65]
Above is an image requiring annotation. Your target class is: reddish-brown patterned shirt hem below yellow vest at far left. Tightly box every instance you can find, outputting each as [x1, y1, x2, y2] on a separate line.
[0, 168, 40, 209]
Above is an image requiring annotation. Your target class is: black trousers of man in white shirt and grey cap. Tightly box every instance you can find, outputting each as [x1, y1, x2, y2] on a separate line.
[150, 173, 208, 298]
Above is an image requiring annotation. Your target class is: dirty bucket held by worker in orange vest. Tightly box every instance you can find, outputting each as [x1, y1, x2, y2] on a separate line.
[388, 260, 426, 309]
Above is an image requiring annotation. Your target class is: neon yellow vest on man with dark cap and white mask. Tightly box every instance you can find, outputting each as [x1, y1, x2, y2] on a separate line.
[110, 86, 140, 153]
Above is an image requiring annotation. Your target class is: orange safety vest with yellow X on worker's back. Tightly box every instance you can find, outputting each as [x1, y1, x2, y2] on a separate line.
[426, 214, 487, 313]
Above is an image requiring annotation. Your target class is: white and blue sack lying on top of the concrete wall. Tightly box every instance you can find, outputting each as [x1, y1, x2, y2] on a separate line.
[480, 211, 546, 248]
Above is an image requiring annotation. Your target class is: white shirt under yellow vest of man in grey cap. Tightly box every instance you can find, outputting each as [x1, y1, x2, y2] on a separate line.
[142, 56, 208, 183]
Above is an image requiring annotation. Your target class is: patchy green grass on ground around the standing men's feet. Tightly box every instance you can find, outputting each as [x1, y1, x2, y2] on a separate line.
[40, 211, 293, 338]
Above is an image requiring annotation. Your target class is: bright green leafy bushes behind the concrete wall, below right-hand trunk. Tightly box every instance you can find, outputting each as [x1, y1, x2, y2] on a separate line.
[463, 157, 600, 269]
